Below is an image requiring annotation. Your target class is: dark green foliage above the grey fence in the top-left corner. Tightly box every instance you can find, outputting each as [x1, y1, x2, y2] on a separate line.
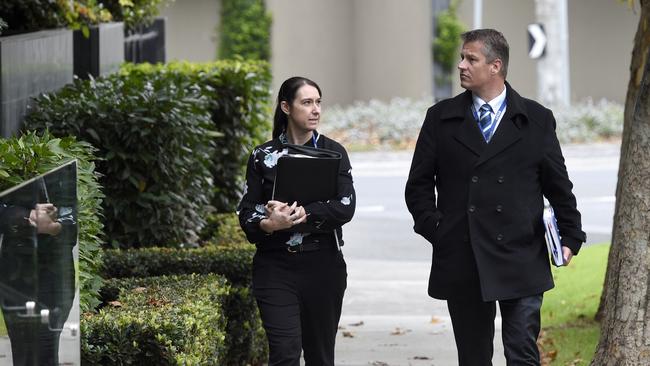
[0, 0, 65, 35]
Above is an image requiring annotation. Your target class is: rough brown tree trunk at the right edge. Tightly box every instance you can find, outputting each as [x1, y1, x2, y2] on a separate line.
[592, 0, 650, 366]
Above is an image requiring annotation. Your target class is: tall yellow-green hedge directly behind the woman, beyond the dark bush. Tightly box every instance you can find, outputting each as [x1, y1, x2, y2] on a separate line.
[122, 61, 271, 212]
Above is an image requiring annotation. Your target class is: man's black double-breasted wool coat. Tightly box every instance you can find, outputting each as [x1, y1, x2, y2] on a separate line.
[406, 83, 585, 301]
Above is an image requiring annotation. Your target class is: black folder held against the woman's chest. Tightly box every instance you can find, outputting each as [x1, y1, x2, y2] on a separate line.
[273, 144, 341, 206]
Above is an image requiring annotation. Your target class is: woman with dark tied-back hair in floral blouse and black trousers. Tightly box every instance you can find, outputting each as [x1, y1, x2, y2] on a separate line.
[238, 77, 355, 366]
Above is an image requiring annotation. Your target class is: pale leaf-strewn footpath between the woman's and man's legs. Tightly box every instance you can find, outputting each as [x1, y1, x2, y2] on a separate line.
[336, 259, 505, 366]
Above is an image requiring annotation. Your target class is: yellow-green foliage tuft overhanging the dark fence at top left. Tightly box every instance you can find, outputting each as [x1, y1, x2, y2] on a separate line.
[99, 0, 173, 30]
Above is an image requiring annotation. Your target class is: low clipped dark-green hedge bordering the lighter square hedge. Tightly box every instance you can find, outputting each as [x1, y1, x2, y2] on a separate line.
[102, 244, 268, 365]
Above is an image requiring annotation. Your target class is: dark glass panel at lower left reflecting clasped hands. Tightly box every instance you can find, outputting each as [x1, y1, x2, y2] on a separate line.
[0, 161, 79, 365]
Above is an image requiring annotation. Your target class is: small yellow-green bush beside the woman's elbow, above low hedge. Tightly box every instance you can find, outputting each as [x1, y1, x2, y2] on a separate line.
[199, 212, 248, 245]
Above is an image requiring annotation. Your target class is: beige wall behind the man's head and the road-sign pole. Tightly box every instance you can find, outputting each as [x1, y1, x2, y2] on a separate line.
[453, 0, 639, 103]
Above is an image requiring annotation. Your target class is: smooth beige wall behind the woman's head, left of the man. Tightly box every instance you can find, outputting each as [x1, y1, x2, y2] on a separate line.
[267, 0, 432, 105]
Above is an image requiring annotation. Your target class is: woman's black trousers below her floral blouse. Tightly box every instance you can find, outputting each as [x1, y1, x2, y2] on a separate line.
[253, 246, 347, 366]
